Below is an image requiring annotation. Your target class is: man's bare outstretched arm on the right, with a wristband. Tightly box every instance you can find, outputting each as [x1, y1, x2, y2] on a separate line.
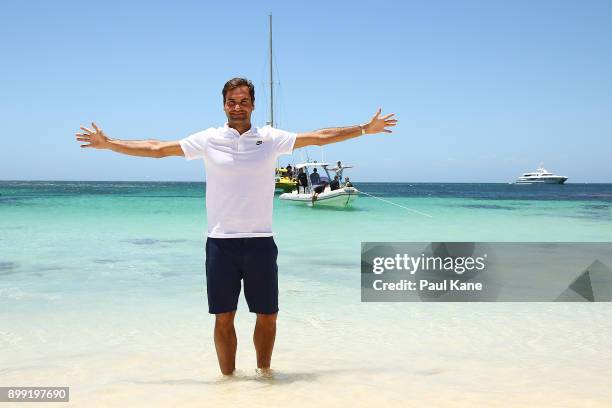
[293, 108, 397, 149]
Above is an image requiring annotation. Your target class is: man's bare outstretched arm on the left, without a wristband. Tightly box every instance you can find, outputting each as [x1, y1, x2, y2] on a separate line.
[76, 122, 185, 158]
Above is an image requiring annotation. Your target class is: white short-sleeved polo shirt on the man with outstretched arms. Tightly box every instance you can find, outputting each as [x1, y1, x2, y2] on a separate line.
[179, 123, 297, 238]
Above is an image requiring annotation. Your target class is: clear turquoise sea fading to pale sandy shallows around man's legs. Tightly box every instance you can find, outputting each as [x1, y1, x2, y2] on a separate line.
[0, 181, 612, 407]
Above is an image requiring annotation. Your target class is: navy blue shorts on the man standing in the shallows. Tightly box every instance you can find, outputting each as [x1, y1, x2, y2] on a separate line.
[206, 237, 278, 314]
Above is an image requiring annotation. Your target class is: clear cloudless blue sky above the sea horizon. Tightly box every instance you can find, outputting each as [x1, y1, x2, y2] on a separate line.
[0, 0, 612, 182]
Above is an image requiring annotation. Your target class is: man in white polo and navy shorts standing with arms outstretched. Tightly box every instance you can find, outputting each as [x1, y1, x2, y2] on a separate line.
[76, 78, 397, 375]
